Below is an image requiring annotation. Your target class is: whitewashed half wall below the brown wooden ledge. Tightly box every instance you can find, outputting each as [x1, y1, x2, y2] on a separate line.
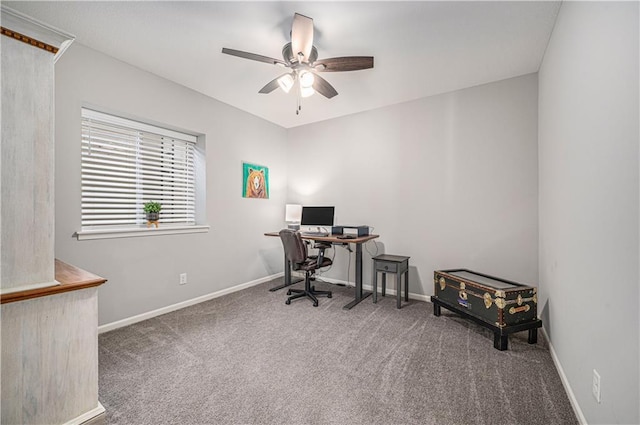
[0, 288, 100, 424]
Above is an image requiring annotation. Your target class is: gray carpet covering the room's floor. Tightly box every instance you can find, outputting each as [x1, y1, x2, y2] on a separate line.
[99, 283, 578, 425]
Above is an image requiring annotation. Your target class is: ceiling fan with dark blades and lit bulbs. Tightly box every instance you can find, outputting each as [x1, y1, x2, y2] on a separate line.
[222, 13, 373, 114]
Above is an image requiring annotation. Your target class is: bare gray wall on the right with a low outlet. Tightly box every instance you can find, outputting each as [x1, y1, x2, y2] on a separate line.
[539, 2, 640, 424]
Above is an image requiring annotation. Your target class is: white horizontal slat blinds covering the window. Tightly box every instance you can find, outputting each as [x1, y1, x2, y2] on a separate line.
[82, 108, 196, 229]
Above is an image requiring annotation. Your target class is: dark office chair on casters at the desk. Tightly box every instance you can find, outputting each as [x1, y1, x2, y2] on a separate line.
[279, 229, 332, 307]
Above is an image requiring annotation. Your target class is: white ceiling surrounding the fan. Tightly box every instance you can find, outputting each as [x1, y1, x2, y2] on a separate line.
[3, 1, 560, 128]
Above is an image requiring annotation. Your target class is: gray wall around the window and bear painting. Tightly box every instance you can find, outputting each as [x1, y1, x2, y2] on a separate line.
[55, 43, 287, 325]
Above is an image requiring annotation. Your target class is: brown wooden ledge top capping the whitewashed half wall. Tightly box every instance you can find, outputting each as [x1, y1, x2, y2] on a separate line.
[0, 259, 107, 304]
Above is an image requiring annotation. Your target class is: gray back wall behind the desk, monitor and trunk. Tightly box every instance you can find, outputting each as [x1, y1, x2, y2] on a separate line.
[288, 74, 538, 295]
